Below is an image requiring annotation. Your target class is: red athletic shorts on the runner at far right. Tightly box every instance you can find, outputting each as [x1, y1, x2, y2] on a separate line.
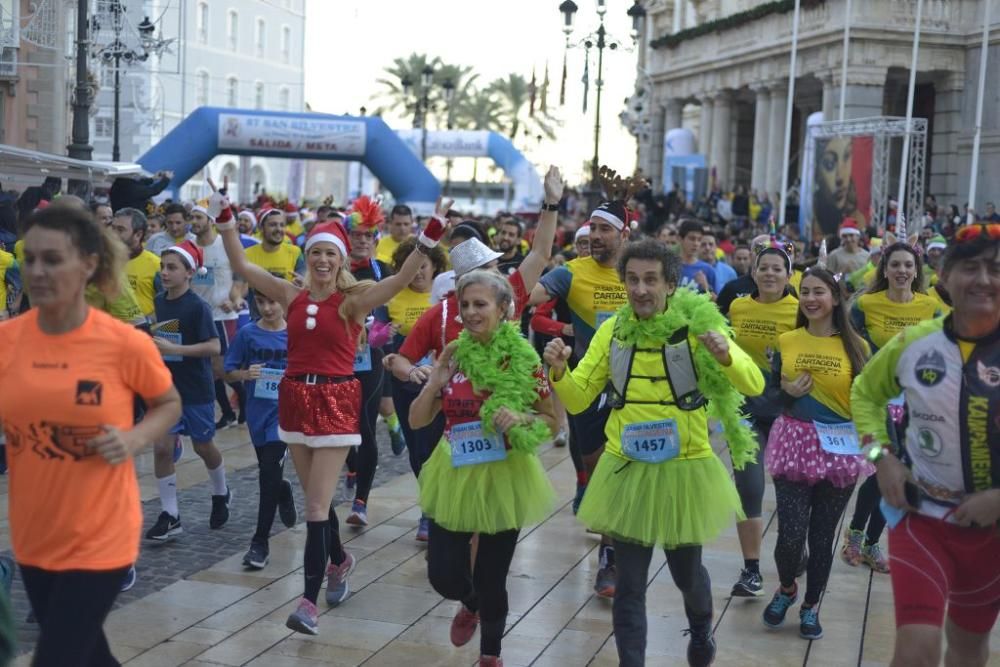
[889, 513, 1000, 634]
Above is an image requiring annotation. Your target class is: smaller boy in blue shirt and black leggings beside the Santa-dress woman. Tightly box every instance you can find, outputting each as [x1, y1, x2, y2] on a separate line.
[225, 292, 297, 570]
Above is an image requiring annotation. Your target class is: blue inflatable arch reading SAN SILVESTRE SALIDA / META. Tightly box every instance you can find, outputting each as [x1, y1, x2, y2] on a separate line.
[138, 107, 441, 213]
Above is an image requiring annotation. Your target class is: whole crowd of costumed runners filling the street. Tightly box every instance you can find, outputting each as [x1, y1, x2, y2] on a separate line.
[0, 167, 1000, 667]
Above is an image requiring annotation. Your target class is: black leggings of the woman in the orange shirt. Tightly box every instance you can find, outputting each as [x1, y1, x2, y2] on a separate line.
[21, 565, 128, 667]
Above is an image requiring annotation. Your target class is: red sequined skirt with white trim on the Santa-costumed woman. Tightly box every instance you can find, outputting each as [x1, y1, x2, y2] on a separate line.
[278, 377, 361, 447]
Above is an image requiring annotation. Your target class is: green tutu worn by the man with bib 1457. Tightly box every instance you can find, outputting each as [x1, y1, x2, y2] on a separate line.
[577, 454, 746, 549]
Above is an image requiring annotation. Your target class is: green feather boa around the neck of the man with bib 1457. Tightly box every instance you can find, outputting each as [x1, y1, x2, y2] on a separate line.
[614, 288, 759, 470]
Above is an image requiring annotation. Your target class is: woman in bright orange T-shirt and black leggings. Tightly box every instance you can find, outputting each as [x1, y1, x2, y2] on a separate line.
[0, 204, 181, 667]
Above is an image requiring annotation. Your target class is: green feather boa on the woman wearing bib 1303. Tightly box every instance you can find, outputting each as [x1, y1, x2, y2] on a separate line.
[454, 322, 552, 454]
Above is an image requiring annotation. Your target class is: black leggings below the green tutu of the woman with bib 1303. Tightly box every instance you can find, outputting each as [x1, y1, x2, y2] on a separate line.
[427, 521, 519, 655]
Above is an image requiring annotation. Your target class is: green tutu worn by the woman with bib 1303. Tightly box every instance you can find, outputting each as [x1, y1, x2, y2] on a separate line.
[418, 440, 555, 534]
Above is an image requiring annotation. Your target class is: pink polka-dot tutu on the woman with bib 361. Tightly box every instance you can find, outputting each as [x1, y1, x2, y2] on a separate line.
[764, 415, 875, 489]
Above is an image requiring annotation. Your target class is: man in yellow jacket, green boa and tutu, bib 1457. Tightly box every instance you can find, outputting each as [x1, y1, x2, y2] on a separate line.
[544, 240, 764, 667]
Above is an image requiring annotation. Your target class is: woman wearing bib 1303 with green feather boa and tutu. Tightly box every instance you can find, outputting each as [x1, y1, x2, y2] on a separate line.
[410, 270, 556, 666]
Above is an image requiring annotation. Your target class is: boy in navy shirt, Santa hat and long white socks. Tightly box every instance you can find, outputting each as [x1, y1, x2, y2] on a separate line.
[146, 241, 232, 542]
